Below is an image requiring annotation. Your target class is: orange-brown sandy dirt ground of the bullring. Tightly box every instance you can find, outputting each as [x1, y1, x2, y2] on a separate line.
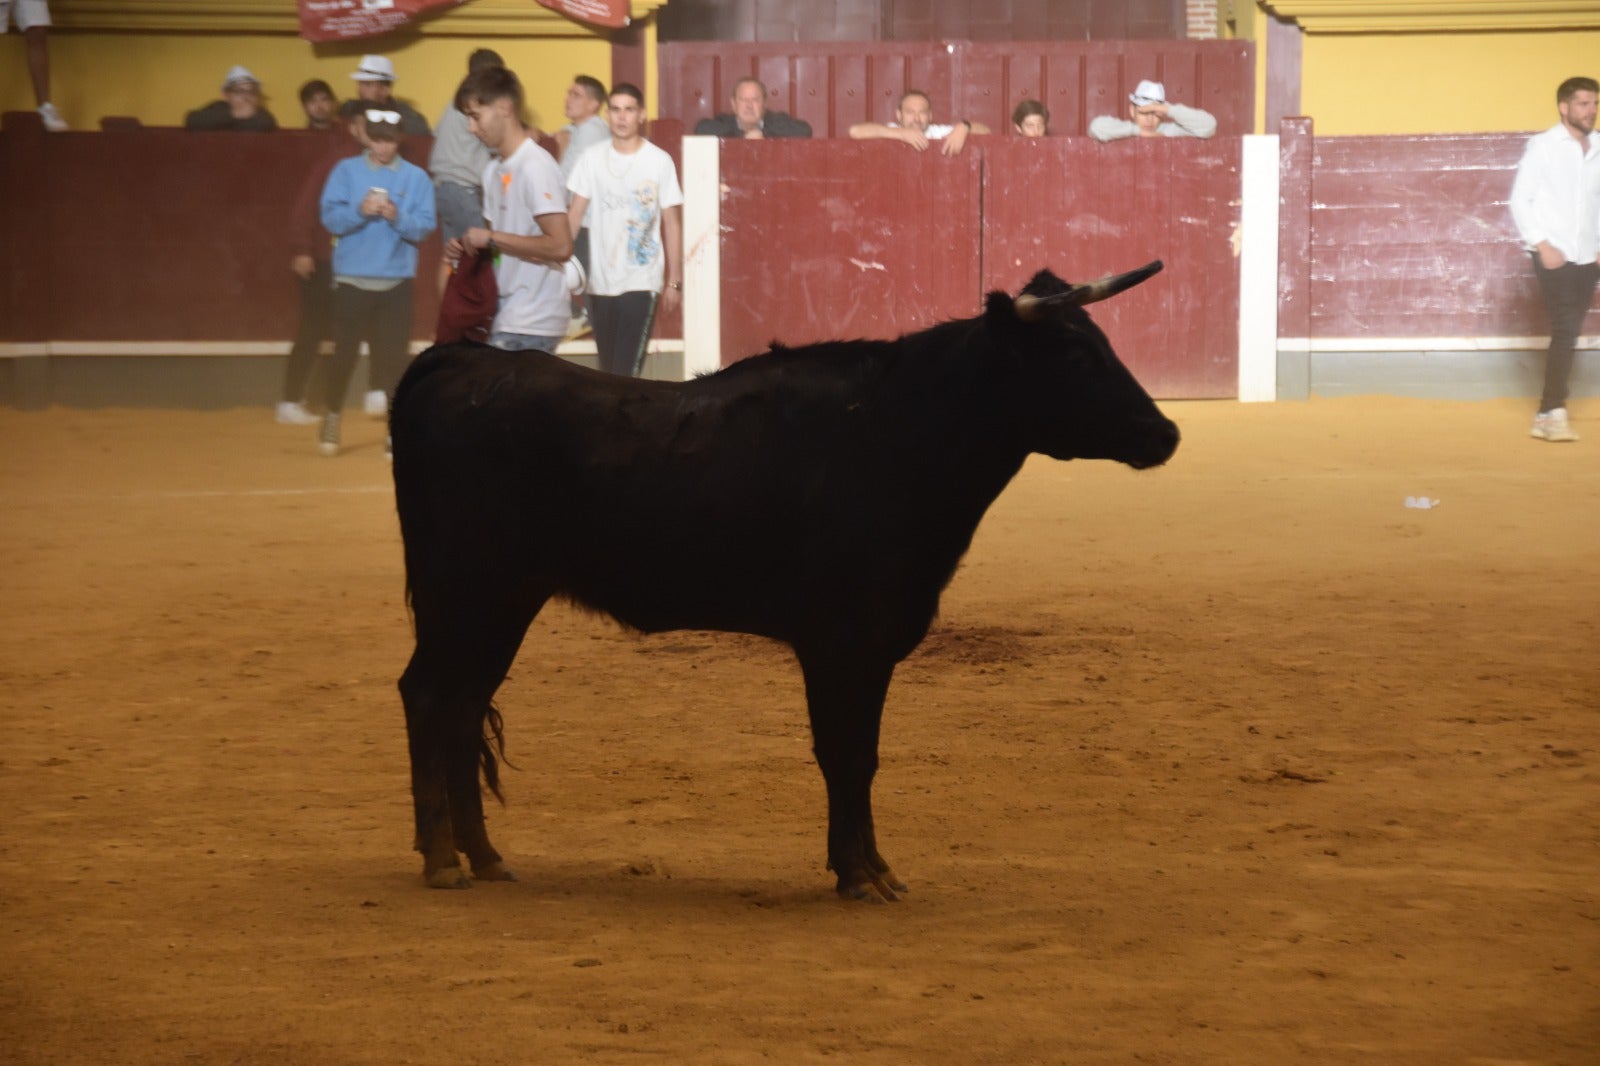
[0, 399, 1600, 1064]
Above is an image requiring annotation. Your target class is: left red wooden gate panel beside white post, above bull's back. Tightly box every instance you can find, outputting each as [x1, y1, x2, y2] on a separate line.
[722, 141, 981, 362]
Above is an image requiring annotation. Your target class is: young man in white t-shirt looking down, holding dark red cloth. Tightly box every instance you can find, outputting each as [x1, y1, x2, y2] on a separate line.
[445, 67, 573, 354]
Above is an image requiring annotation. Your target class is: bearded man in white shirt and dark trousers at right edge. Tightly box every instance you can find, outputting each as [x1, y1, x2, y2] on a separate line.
[1510, 77, 1600, 442]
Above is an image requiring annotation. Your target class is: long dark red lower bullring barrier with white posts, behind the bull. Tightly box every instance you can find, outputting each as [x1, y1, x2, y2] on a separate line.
[0, 114, 1600, 407]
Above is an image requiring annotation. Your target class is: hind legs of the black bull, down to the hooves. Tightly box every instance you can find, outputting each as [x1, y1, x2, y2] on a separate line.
[400, 600, 542, 888]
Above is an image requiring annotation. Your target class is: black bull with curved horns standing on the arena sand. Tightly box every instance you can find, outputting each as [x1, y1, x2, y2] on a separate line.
[390, 262, 1178, 900]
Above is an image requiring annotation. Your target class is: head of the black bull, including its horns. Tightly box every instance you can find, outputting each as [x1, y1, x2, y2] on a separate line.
[984, 261, 1178, 469]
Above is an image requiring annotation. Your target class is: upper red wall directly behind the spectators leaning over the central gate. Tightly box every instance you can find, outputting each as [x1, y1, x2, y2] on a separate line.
[659, 40, 1256, 138]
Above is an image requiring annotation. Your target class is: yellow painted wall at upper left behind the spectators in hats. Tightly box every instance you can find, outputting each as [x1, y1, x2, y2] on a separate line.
[0, 30, 611, 131]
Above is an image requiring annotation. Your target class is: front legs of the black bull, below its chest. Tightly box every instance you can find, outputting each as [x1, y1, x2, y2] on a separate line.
[800, 651, 906, 900]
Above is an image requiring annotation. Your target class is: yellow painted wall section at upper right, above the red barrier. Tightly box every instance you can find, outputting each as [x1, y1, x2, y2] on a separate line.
[1301, 30, 1600, 136]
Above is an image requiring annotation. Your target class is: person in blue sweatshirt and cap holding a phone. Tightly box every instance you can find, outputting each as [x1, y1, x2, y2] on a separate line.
[318, 107, 435, 456]
